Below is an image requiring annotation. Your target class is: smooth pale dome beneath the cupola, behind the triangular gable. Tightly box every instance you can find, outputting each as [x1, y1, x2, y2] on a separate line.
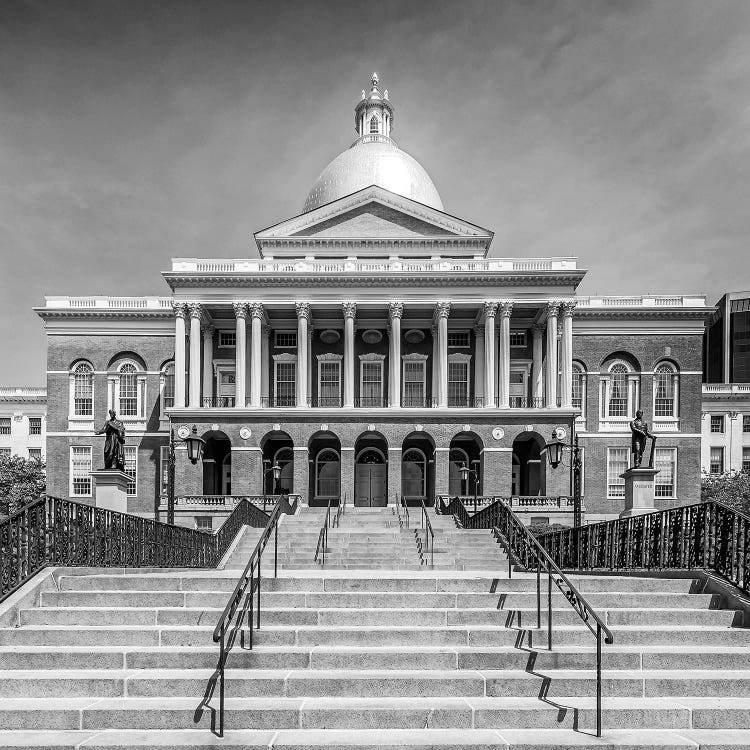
[304, 136, 443, 212]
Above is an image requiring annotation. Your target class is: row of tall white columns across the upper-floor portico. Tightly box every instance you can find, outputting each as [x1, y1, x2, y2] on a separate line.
[173, 300, 575, 409]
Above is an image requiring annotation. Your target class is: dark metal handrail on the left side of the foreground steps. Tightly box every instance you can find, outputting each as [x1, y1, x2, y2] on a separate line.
[213, 500, 294, 737]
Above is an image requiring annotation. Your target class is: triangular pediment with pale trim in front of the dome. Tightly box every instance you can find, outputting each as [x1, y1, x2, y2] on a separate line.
[255, 185, 492, 247]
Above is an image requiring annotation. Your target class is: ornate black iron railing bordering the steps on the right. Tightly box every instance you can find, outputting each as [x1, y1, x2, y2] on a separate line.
[539, 501, 750, 593]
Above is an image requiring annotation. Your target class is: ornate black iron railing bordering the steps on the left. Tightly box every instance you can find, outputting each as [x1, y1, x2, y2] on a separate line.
[0, 495, 267, 601]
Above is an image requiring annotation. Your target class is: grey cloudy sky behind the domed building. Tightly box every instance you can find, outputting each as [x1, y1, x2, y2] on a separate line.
[0, 0, 750, 386]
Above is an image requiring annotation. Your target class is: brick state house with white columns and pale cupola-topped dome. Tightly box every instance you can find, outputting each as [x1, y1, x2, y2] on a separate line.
[38, 76, 711, 528]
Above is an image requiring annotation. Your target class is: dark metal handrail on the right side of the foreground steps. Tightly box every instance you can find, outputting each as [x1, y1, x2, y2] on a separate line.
[493, 500, 614, 737]
